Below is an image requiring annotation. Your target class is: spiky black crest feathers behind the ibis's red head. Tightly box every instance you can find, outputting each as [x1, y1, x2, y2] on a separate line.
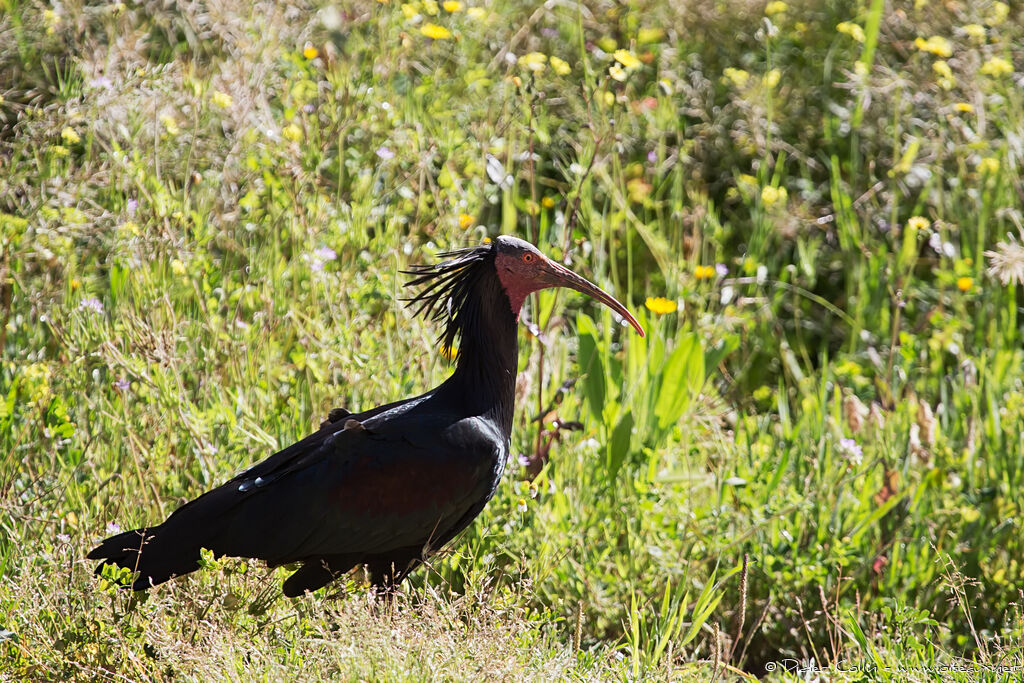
[402, 243, 496, 350]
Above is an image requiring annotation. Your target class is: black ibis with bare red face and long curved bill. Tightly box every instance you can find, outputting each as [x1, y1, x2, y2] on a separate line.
[89, 236, 644, 596]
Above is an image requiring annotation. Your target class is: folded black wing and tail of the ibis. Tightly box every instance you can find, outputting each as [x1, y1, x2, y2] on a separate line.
[90, 407, 507, 588]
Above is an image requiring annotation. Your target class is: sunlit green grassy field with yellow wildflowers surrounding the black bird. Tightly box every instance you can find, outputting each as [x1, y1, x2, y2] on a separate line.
[0, 0, 1024, 681]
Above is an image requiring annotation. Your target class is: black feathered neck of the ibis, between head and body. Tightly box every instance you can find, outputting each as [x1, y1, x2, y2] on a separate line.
[445, 275, 519, 436]
